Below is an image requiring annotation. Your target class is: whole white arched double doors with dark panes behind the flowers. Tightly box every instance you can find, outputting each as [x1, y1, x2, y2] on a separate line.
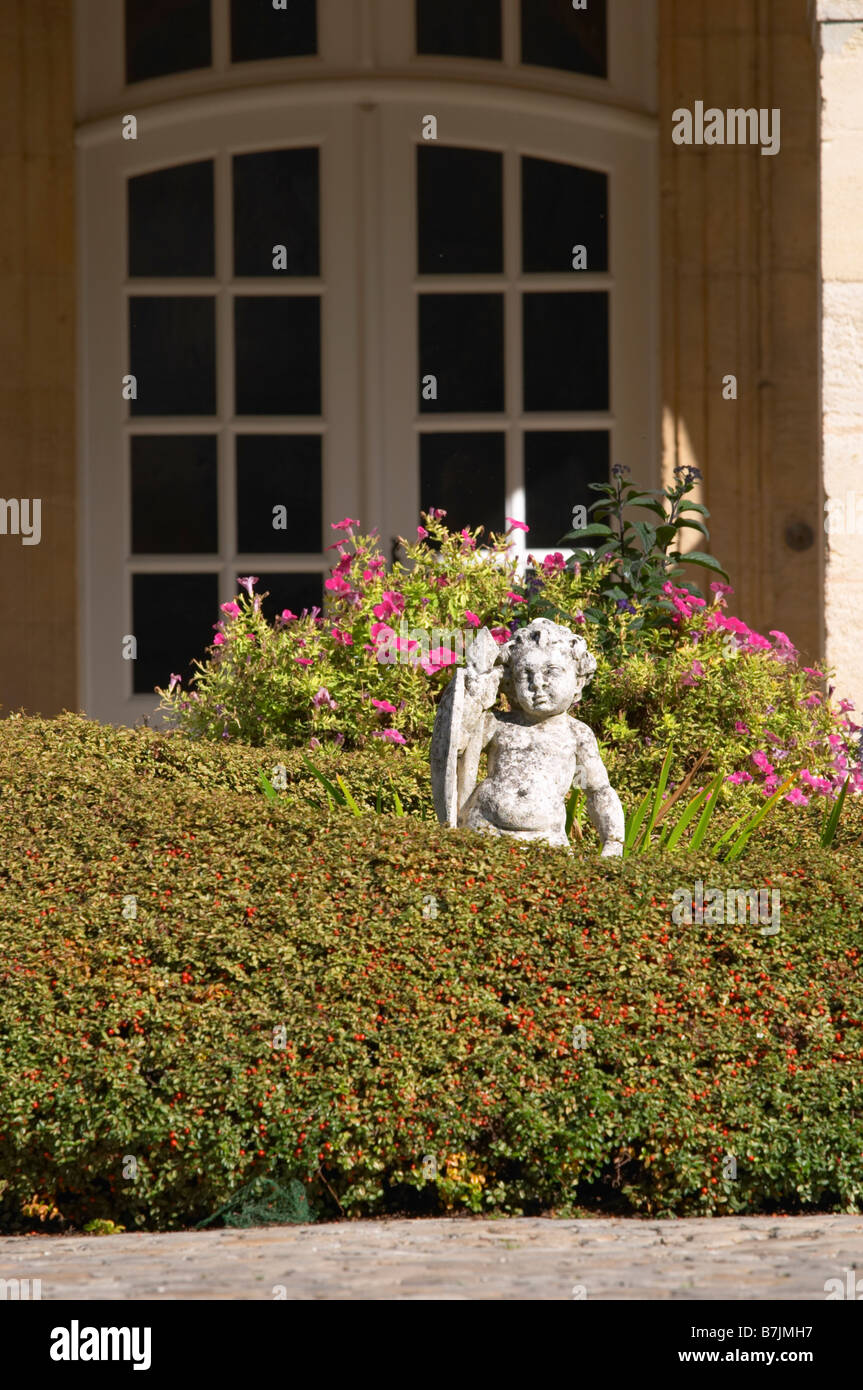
[79, 0, 657, 723]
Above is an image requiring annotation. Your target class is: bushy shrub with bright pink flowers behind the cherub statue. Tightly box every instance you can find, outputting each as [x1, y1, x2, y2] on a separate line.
[163, 511, 863, 809]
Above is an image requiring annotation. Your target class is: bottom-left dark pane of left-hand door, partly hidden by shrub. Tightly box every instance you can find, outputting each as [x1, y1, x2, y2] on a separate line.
[132, 574, 220, 695]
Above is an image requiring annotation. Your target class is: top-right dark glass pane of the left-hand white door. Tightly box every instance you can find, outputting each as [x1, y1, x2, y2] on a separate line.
[233, 149, 320, 275]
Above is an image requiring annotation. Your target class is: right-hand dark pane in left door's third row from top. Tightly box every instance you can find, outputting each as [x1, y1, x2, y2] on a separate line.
[236, 435, 324, 555]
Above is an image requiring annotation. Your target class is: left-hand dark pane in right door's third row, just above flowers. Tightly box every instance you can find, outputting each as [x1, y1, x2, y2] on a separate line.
[420, 431, 506, 532]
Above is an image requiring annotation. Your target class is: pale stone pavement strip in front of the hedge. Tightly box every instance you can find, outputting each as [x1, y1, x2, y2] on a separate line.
[0, 1216, 863, 1300]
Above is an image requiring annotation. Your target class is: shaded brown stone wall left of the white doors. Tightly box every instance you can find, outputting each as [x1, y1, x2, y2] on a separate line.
[0, 0, 78, 717]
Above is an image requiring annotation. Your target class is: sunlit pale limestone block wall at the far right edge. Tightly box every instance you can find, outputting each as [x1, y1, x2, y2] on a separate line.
[813, 0, 863, 712]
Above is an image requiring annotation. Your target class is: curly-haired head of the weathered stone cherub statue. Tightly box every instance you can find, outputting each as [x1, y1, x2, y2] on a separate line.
[499, 617, 596, 720]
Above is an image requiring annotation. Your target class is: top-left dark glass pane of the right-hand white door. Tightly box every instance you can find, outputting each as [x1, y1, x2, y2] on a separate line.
[417, 145, 503, 275]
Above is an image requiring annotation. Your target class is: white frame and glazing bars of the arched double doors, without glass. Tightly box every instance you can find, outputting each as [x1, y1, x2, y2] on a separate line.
[78, 0, 659, 724]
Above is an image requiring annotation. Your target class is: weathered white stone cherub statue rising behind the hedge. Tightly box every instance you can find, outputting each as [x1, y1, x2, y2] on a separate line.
[431, 617, 624, 858]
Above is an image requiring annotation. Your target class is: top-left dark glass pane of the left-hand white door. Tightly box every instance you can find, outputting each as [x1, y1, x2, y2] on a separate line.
[129, 160, 215, 275]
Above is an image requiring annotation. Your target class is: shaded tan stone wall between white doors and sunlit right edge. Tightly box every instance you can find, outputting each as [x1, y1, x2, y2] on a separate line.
[659, 0, 824, 659]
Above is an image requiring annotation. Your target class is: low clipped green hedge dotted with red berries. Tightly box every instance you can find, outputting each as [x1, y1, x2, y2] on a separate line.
[0, 716, 863, 1230]
